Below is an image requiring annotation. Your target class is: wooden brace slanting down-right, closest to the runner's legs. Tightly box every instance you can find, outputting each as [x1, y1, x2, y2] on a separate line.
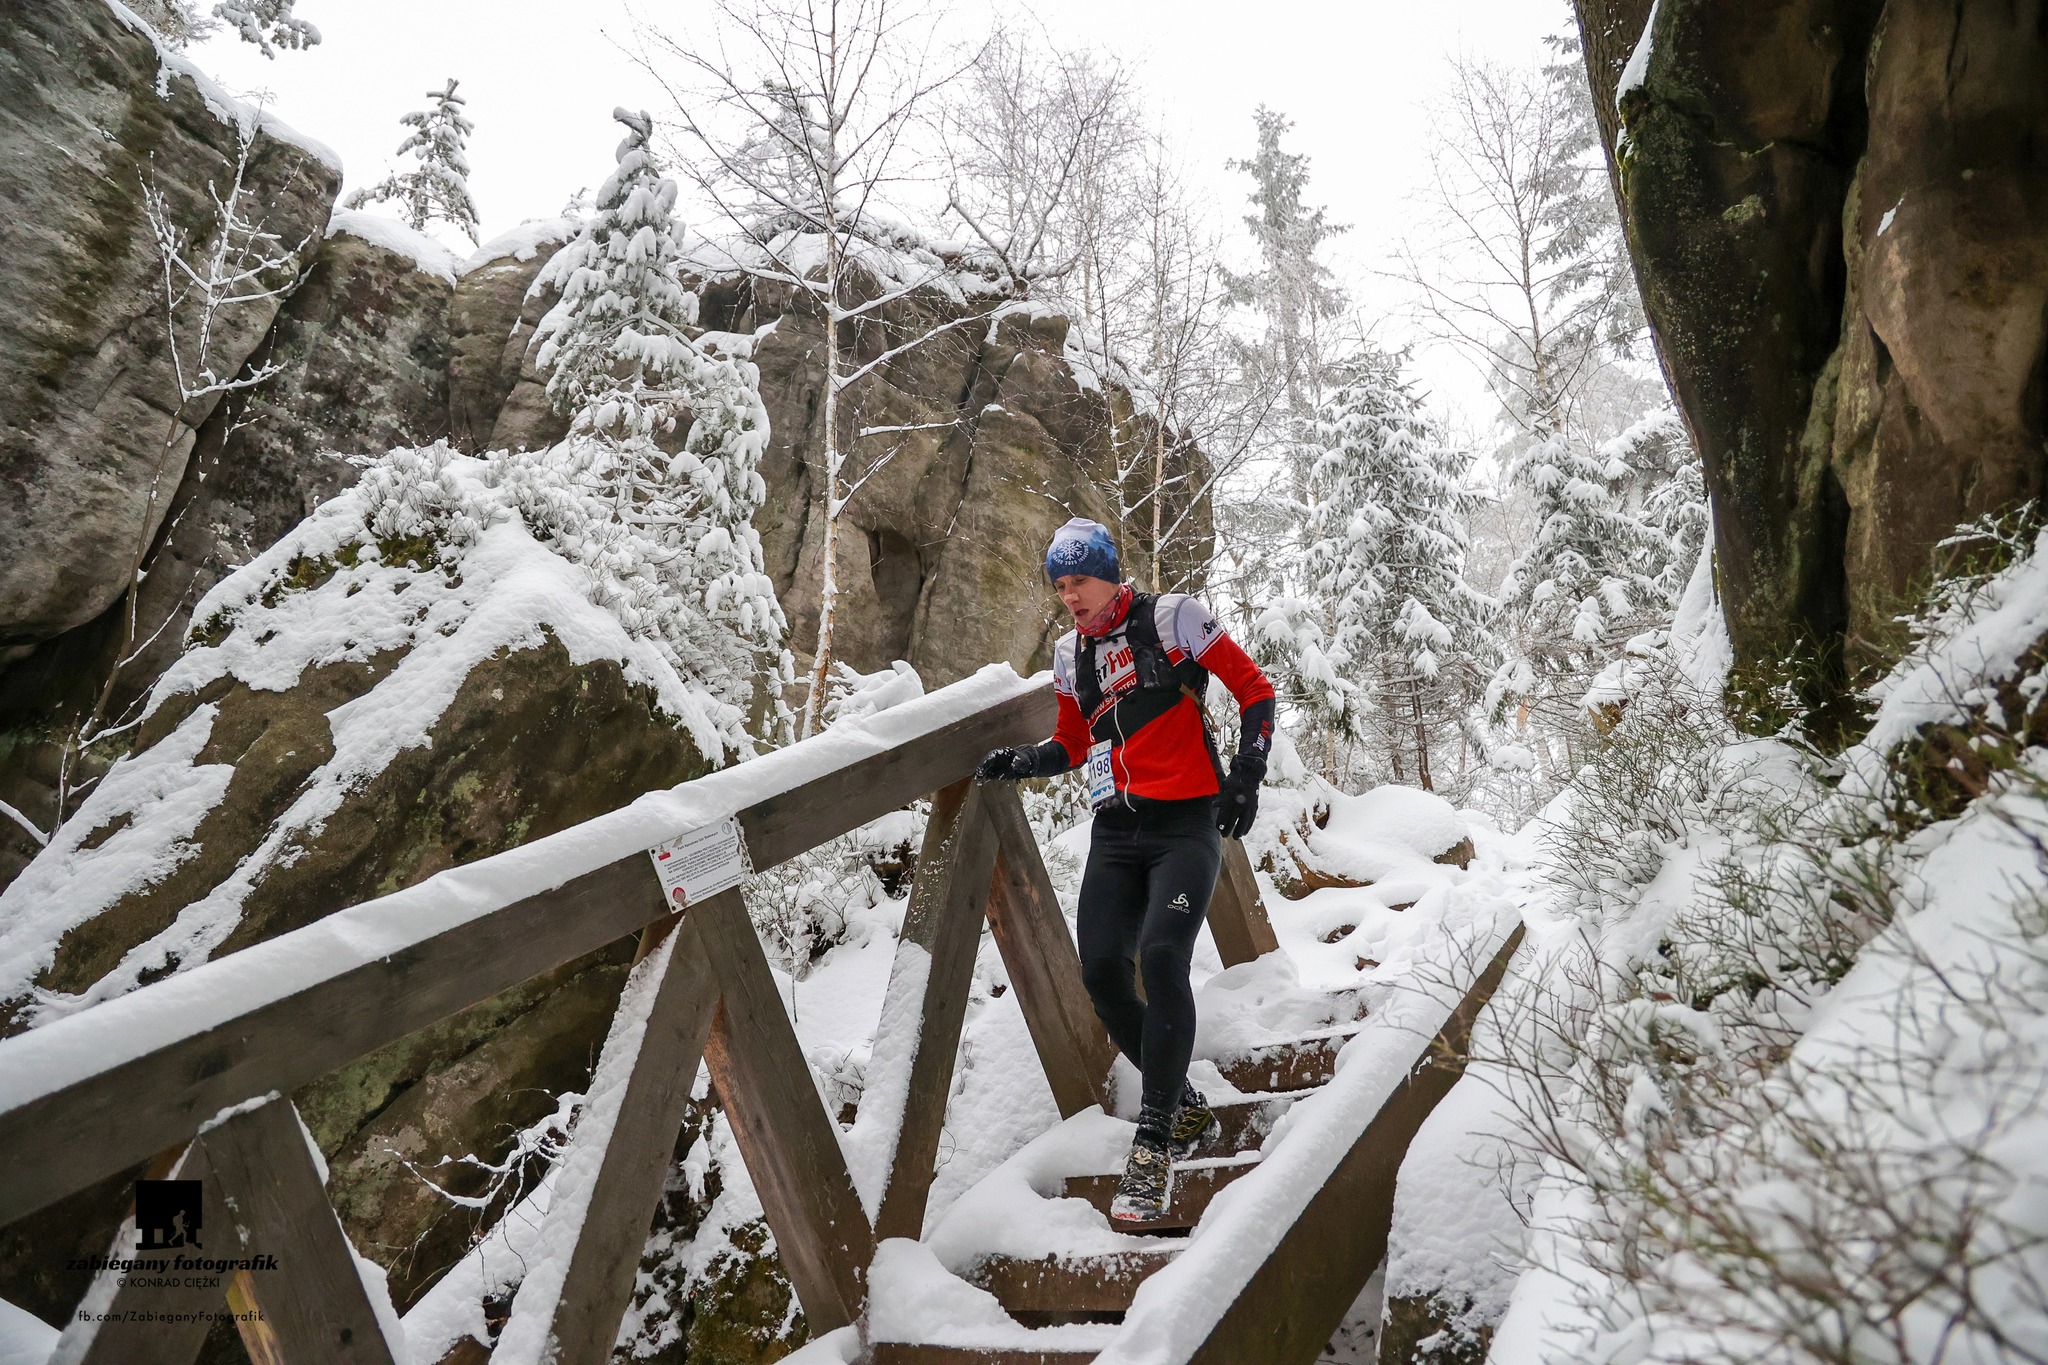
[981, 782, 1116, 1119]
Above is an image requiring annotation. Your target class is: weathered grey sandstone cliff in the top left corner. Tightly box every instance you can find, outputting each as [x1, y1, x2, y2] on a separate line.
[0, 2, 340, 659]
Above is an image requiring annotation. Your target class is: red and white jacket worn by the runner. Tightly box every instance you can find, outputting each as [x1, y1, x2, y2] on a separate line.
[1053, 593, 1274, 800]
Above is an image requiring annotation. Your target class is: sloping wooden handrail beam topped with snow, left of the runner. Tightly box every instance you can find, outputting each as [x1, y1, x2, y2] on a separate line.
[0, 673, 1053, 1224]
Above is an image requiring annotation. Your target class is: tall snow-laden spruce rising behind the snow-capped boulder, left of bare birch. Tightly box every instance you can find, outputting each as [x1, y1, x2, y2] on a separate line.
[537, 108, 784, 706]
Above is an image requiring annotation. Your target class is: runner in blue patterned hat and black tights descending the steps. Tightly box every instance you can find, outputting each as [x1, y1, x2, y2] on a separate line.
[975, 518, 1274, 1222]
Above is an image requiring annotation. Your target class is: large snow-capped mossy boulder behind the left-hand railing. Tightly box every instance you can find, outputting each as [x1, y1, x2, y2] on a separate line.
[0, 446, 743, 1312]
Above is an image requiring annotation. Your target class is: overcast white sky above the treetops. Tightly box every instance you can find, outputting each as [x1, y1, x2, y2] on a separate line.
[188, 0, 1569, 417]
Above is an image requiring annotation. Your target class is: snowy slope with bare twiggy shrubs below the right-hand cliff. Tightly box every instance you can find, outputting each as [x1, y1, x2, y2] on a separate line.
[1482, 538, 2048, 1365]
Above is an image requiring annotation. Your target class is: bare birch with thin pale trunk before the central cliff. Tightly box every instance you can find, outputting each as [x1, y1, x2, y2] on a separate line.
[643, 0, 991, 737]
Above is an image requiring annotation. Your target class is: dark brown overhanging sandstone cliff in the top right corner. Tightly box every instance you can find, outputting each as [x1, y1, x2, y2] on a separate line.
[1577, 0, 2048, 690]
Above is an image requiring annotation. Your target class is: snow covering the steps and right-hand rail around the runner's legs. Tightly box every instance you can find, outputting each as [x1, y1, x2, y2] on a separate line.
[870, 773, 1516, 1361]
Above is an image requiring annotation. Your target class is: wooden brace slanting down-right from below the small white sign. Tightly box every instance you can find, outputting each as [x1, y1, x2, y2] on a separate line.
[690, 894, 874, 1336]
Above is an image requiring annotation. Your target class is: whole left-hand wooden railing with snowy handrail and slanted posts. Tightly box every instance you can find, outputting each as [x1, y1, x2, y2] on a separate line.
[0, 665, 1274, 1365]
